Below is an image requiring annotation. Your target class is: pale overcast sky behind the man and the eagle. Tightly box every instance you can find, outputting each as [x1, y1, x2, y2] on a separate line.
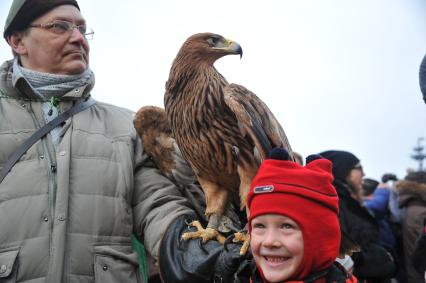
[0, 0, 426, 181]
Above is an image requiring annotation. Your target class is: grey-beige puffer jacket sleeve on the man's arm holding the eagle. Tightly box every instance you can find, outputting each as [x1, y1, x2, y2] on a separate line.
[133, 138, 194, 261]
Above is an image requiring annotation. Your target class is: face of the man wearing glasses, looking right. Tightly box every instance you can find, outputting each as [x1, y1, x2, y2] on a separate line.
[12, 5, 89, 75]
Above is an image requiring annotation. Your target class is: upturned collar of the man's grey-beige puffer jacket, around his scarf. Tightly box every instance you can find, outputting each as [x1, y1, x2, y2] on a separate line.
[0, 60, 95, 100]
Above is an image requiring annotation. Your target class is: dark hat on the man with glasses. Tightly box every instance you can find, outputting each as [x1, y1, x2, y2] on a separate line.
[3, 0, 80, 38]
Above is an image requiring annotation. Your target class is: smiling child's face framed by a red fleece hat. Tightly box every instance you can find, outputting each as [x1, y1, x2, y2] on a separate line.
[250, 214, 304, 283]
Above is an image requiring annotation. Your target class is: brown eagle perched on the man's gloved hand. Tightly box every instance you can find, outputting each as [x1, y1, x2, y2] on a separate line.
[164, 33, 292, 247]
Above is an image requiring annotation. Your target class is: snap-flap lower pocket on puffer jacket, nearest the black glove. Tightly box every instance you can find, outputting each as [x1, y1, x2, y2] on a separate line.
[94, 246, 143, 283]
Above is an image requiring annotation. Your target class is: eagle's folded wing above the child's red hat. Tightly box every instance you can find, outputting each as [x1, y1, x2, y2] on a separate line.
[224, 84, 293, 160]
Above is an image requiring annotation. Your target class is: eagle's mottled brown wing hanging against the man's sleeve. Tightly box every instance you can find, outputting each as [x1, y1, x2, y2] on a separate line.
[133, 106, 195, 185]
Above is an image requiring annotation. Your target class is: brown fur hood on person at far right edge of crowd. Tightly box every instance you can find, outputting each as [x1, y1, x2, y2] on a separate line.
[396, 180, 426, 206]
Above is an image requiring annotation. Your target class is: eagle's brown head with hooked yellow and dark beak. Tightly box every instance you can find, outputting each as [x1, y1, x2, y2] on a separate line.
[176, 32, 243, 65]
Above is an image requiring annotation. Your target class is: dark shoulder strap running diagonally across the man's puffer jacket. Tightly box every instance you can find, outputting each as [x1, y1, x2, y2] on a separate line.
[0, 97, 96, 183]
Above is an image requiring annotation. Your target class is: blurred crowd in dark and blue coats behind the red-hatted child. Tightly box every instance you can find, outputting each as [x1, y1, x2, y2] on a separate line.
[299, 150, 426, 283]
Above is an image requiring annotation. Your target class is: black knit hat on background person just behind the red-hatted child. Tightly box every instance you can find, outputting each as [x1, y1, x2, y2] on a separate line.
[320, 150, 359, 181]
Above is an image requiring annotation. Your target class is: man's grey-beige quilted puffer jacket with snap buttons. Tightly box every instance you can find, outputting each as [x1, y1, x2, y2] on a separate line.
[0, 61, 190, 283]
